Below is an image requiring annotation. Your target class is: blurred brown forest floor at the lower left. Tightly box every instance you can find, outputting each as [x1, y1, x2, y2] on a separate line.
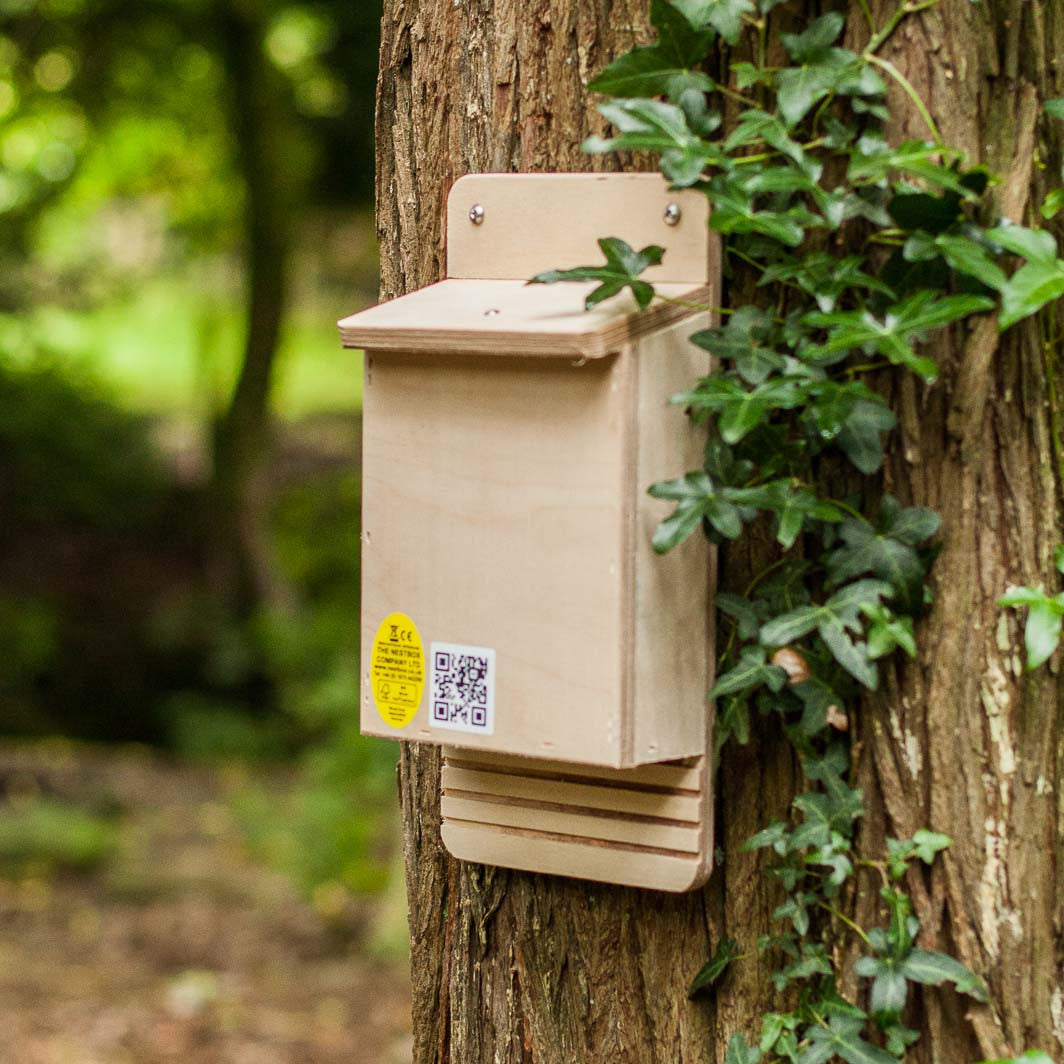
[0, 744, 411, 1064]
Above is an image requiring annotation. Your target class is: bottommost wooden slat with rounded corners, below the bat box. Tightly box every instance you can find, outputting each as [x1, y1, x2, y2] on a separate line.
[440, 820, 706, 891]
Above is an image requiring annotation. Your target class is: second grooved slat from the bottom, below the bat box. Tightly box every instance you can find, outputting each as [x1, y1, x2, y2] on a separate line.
[440, 794, 701, 853]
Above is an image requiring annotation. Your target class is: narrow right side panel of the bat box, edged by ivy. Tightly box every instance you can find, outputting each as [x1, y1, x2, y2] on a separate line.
[629, 315, 715, 764]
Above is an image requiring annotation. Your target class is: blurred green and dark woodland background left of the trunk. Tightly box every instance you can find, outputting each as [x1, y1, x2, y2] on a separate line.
[0, 0, 393, 927]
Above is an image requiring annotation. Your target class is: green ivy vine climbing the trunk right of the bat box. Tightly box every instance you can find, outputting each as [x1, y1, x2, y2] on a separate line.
[533, 0, 1064, 1064]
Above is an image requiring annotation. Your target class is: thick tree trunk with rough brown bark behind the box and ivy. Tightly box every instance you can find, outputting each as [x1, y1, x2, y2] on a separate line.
[377, 0, 1064, 1064]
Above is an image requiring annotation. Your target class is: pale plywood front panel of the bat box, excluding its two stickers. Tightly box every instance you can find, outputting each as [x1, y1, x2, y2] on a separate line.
[361, 352, 627, 765]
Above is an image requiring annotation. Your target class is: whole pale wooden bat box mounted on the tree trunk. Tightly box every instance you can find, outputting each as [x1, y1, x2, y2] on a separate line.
[339, 174, 718, 890]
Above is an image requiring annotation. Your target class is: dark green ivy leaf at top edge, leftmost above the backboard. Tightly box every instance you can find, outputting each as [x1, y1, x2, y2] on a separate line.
[587, 0, 714, 100]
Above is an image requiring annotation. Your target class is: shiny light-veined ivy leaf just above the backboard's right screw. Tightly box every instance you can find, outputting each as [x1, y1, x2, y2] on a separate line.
[583, 99, 715, 188]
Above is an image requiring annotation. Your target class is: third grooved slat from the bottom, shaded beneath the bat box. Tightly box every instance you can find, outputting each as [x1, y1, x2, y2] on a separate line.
[443, 765, 702, 824]
